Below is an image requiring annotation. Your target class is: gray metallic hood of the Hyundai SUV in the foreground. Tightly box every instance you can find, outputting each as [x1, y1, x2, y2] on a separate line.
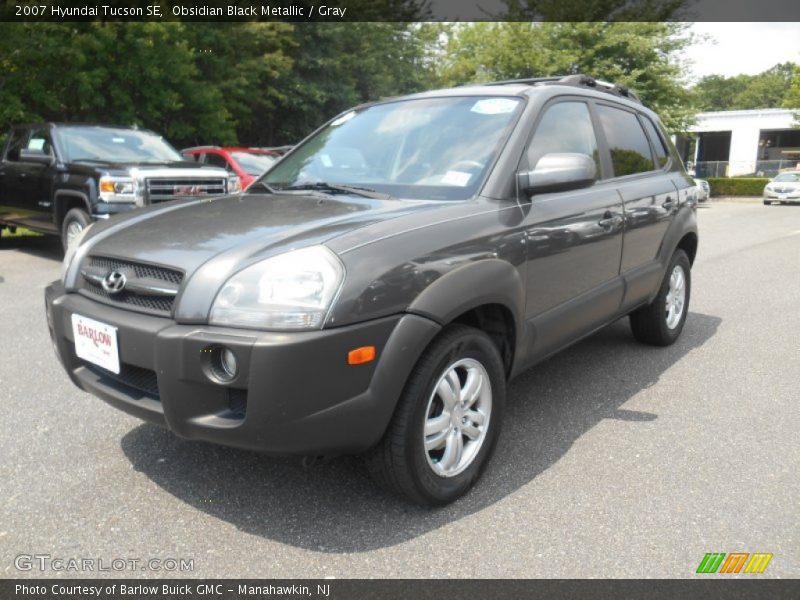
[81, 193, 446, 322]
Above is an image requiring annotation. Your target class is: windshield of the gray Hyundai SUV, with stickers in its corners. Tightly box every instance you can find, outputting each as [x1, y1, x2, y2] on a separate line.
[263, 96, 522, 200]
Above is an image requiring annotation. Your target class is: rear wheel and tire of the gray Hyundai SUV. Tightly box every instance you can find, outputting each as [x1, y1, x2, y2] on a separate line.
[630, 250, 692, 346]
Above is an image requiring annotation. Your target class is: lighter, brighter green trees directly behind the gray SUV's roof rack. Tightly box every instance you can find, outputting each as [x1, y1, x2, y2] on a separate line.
[440, 22, 693, 131]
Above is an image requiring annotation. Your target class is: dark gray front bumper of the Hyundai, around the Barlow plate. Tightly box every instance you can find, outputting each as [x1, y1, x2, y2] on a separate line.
[45, 282, 440, 455]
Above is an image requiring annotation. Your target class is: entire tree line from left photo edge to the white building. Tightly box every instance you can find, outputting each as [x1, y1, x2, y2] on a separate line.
[0, 20, 691, 147]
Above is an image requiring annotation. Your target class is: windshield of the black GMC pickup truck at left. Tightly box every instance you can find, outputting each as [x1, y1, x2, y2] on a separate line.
[55, 127, 183, 163]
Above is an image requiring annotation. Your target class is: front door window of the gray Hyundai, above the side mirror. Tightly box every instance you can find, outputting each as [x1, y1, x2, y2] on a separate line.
[527, 102, 600, 173]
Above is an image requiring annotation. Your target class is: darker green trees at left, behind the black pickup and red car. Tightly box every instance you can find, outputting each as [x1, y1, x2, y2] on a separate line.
[0, 22, 432, 147]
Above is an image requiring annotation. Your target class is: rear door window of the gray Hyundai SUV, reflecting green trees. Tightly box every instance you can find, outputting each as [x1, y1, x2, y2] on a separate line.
[597, 104, 655, 177]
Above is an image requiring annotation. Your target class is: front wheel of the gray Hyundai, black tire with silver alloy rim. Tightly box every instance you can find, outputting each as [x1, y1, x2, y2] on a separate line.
[365, 324, 506, 506]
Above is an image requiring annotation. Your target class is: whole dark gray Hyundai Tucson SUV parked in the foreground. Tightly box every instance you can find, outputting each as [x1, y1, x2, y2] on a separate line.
[46, 76, 698, 505]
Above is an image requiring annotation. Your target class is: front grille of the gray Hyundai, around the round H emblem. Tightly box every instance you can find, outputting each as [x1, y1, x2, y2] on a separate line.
[79, 256, 183, 316]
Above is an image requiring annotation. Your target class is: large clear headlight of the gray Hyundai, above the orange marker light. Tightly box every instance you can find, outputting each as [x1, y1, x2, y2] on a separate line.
[209, 246, 344, 330]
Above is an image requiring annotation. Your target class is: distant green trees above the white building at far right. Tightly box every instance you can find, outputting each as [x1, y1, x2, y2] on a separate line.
[692, 63, 800, 111]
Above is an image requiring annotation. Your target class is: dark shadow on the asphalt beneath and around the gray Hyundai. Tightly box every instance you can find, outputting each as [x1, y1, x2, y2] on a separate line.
[121, 313, 721, 553]
